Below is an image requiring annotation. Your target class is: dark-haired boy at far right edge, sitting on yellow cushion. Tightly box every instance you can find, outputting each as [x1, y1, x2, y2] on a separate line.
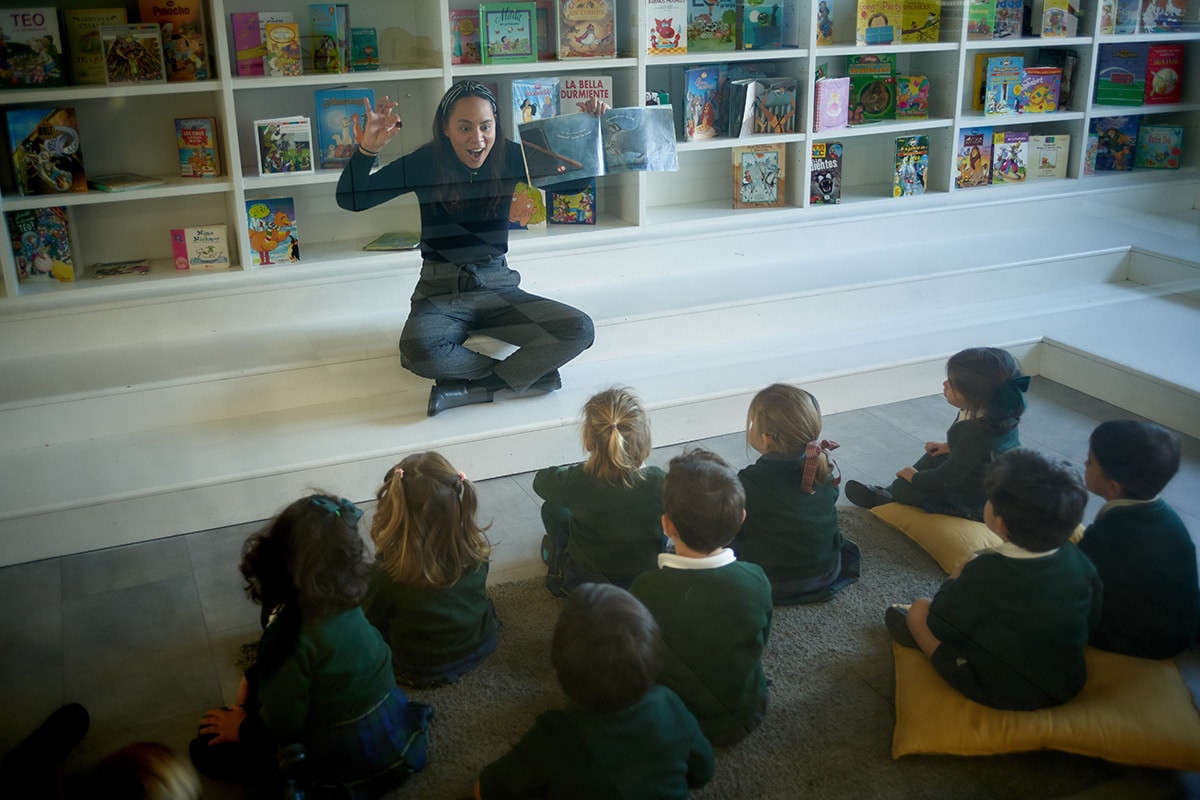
[1079, 420, 1200, 658]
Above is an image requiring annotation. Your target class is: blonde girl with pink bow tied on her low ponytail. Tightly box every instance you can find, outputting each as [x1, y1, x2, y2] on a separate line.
[730, 384, 862, 606]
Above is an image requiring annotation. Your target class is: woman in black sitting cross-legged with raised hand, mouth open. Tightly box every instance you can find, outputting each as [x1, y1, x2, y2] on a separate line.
[337, 80, 608, 416]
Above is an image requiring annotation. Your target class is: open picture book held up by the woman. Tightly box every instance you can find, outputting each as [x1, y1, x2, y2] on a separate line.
[521, 106, 679, 188]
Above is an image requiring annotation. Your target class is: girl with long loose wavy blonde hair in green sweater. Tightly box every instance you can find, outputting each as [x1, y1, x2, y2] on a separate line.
[362, 452, 499, 688]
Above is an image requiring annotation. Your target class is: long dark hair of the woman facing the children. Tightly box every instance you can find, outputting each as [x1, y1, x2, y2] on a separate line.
[430, 80, 508, 213]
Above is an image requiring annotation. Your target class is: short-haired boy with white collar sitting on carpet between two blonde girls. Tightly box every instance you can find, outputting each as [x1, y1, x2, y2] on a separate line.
[630, 450, 773, 747]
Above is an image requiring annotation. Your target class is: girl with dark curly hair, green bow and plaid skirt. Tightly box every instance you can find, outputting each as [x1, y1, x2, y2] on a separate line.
[191, 494, 432, 798]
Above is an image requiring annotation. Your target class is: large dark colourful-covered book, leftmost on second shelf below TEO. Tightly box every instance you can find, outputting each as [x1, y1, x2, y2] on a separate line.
[5, 107, 88, 194]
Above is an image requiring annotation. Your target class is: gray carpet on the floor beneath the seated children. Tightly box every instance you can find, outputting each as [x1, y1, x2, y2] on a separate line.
[392, 509, 1142, 800]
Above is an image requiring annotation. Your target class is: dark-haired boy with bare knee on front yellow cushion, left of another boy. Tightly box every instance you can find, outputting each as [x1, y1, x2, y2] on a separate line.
[884, 449, 1102, 710]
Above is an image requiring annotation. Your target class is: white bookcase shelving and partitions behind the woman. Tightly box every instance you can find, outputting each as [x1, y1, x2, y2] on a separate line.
[0, 0, 1200, 299]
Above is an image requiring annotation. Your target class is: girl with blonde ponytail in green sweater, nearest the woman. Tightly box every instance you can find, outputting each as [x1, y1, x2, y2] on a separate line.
[533, 386, 665, 596]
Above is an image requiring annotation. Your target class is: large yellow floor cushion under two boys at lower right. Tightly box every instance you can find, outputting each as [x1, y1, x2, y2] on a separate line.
[892, 643, 1200, 771]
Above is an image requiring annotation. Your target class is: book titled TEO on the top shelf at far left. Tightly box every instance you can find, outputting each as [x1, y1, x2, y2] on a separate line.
[0, 6, 67, 89]
